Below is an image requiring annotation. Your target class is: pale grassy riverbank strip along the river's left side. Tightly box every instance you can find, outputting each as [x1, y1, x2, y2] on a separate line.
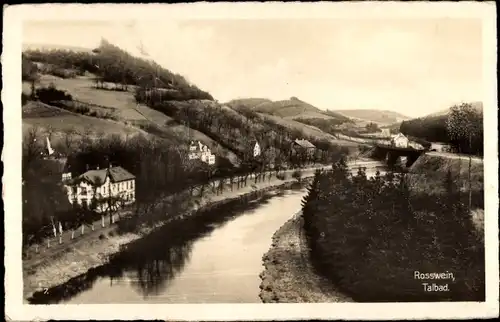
[23, 169, 315, 299]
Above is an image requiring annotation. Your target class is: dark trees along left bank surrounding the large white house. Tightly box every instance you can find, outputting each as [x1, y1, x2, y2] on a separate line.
[22, 123, 348, 244]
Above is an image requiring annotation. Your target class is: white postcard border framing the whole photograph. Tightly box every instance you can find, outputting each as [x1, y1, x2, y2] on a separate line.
[2, 2, 499, 321]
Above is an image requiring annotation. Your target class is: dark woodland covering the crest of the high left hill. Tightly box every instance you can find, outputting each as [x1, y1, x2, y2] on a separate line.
[23, 39, 213, 100]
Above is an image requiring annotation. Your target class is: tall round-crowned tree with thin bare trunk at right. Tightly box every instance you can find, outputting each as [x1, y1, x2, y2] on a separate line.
[446, 103, 482, 211]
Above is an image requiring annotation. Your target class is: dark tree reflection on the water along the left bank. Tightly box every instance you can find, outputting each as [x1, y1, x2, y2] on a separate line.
[29, 186, 300, 304]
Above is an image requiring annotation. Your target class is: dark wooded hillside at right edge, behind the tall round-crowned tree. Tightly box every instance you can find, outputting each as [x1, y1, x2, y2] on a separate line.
[400, 104, 483, 155]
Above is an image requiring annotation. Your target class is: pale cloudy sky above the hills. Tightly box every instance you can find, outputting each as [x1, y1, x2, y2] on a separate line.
[23, 18, 483, 117]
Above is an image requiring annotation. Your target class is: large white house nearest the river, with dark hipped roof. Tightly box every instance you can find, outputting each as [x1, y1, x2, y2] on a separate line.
[62, 166, 135, 212]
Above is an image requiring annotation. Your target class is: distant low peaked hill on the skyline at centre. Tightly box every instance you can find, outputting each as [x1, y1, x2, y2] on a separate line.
[226, 97, 349, 122]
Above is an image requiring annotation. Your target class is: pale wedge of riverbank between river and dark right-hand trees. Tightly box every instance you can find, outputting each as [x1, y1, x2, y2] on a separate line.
[259, 212, 352, 303]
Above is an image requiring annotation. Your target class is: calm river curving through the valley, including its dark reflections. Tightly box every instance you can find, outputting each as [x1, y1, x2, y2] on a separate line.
[28, 181, 309, 304]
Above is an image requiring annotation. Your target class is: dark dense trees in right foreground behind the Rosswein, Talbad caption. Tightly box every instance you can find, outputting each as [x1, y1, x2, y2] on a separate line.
[303, 160, 485, 302]
